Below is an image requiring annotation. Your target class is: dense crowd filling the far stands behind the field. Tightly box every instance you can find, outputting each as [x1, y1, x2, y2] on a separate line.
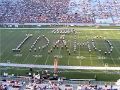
[0, 0, 120, 23]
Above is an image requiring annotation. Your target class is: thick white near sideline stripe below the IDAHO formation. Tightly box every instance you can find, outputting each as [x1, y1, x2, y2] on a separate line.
[0, 63, 120, 71]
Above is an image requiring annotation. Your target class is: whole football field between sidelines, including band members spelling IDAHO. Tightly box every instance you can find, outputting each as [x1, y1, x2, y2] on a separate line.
[0, 28, 120, 67]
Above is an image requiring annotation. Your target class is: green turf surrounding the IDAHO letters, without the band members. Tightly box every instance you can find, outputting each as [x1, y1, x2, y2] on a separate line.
[0, 27, 120, 66]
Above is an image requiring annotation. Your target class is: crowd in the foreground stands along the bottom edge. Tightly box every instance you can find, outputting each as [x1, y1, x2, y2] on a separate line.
[0, 80, 119, 90]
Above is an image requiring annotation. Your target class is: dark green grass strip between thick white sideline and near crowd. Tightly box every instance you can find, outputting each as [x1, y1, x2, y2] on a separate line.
[0, 67, 120, 82]
